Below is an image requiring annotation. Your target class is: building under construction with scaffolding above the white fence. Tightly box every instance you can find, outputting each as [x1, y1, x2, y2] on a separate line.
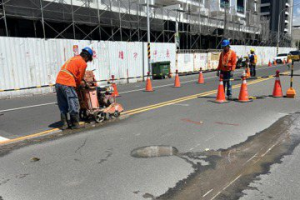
[0, 0, 285, 49]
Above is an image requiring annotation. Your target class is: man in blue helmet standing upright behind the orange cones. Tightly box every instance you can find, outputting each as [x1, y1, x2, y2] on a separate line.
[217, 40, 237, 100]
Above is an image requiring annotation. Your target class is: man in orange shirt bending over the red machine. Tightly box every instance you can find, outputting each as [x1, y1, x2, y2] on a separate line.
[55, 47, 93, 130]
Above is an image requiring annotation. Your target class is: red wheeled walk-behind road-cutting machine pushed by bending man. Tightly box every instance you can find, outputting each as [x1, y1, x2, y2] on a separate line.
[77, 71, 124, 123]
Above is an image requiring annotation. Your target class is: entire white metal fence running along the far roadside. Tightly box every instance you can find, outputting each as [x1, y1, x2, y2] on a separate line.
[0, 37, 295, 98]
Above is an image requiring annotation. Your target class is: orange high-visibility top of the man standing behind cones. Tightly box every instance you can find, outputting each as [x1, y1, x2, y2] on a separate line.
[217, 49, 237, 71]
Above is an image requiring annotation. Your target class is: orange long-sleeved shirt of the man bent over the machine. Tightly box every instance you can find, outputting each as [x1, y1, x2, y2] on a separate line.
[56, 56, 87, 87]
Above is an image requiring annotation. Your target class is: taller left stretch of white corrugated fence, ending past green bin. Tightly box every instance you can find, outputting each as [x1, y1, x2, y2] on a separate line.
[0, 37, 176, 98]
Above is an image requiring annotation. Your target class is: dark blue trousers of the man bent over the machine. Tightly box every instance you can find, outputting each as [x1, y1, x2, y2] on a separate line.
[55, 84, 80, 116]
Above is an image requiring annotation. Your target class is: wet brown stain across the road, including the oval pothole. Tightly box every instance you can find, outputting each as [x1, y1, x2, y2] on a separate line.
[131, 114, 300, 200]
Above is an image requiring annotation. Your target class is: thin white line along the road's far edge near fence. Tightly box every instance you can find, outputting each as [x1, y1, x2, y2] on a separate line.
[0, 67, 282, 113]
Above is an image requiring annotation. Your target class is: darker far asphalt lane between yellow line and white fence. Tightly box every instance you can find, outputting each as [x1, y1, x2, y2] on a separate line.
[0, 66, 287, 139]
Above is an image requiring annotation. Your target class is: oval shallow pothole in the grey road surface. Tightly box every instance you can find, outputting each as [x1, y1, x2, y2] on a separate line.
[131, 145, 178, 158]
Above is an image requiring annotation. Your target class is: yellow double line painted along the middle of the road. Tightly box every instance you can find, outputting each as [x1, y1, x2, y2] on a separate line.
[0, 72, 278, 145]
